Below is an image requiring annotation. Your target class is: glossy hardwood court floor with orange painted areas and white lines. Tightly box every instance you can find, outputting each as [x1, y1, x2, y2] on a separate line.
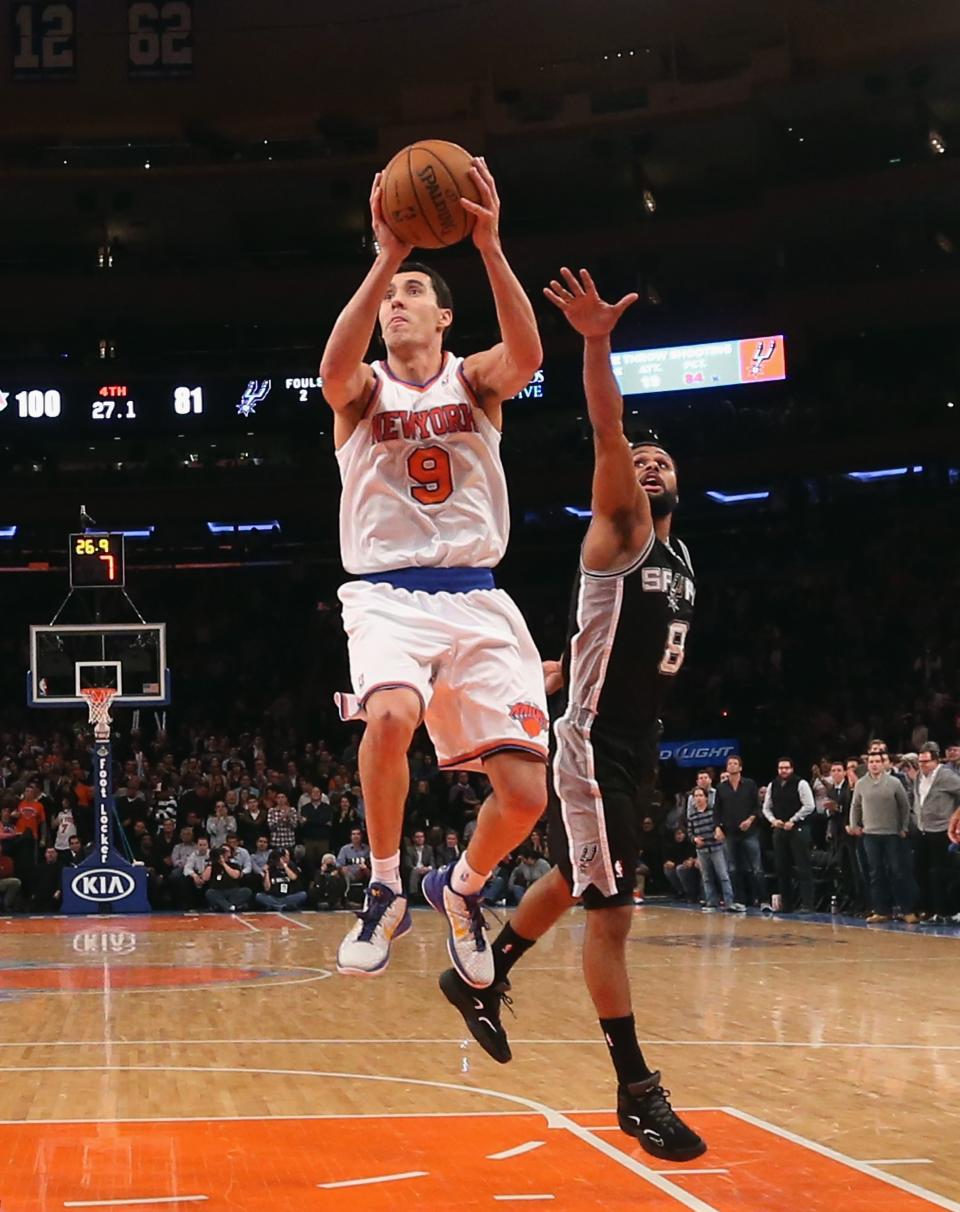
[0, 907, 960, 1212]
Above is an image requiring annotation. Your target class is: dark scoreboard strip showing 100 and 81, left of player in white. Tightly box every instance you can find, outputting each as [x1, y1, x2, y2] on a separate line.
[0, 371, 328, 441]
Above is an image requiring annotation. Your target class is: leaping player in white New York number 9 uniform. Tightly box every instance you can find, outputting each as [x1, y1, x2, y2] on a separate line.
[320, 153, 548, 988]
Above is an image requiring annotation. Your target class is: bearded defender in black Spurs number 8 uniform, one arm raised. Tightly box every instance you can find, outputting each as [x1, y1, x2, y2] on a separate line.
[440, 268, 707, 1161]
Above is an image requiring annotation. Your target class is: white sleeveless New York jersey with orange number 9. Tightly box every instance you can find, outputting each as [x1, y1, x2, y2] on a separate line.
[337, 353, 510, 576]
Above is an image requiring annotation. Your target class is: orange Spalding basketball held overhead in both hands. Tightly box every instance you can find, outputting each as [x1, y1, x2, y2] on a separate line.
[381, 139, 480, 248]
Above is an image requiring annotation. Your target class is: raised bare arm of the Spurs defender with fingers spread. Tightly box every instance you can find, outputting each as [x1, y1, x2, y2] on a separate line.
[543, 265, 650, 525]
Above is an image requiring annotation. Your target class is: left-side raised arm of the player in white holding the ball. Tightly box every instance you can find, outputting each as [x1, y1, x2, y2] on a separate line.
[320, 172, 410, 412]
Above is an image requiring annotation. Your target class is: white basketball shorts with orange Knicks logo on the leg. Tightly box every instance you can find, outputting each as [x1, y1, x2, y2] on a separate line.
[336, 581, 549, 771]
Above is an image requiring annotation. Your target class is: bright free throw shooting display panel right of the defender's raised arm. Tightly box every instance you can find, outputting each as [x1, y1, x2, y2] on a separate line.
[611, 335, 787, 395]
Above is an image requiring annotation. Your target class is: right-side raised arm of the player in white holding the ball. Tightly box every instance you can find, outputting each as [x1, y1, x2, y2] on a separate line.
[461, 158, 543, 402]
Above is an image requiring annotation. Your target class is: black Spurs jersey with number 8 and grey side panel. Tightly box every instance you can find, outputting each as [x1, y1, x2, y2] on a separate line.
[564, 533, 696, 736]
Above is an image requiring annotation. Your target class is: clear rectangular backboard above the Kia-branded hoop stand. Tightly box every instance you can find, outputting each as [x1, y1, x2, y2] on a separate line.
[27, 623, 170, 707]
